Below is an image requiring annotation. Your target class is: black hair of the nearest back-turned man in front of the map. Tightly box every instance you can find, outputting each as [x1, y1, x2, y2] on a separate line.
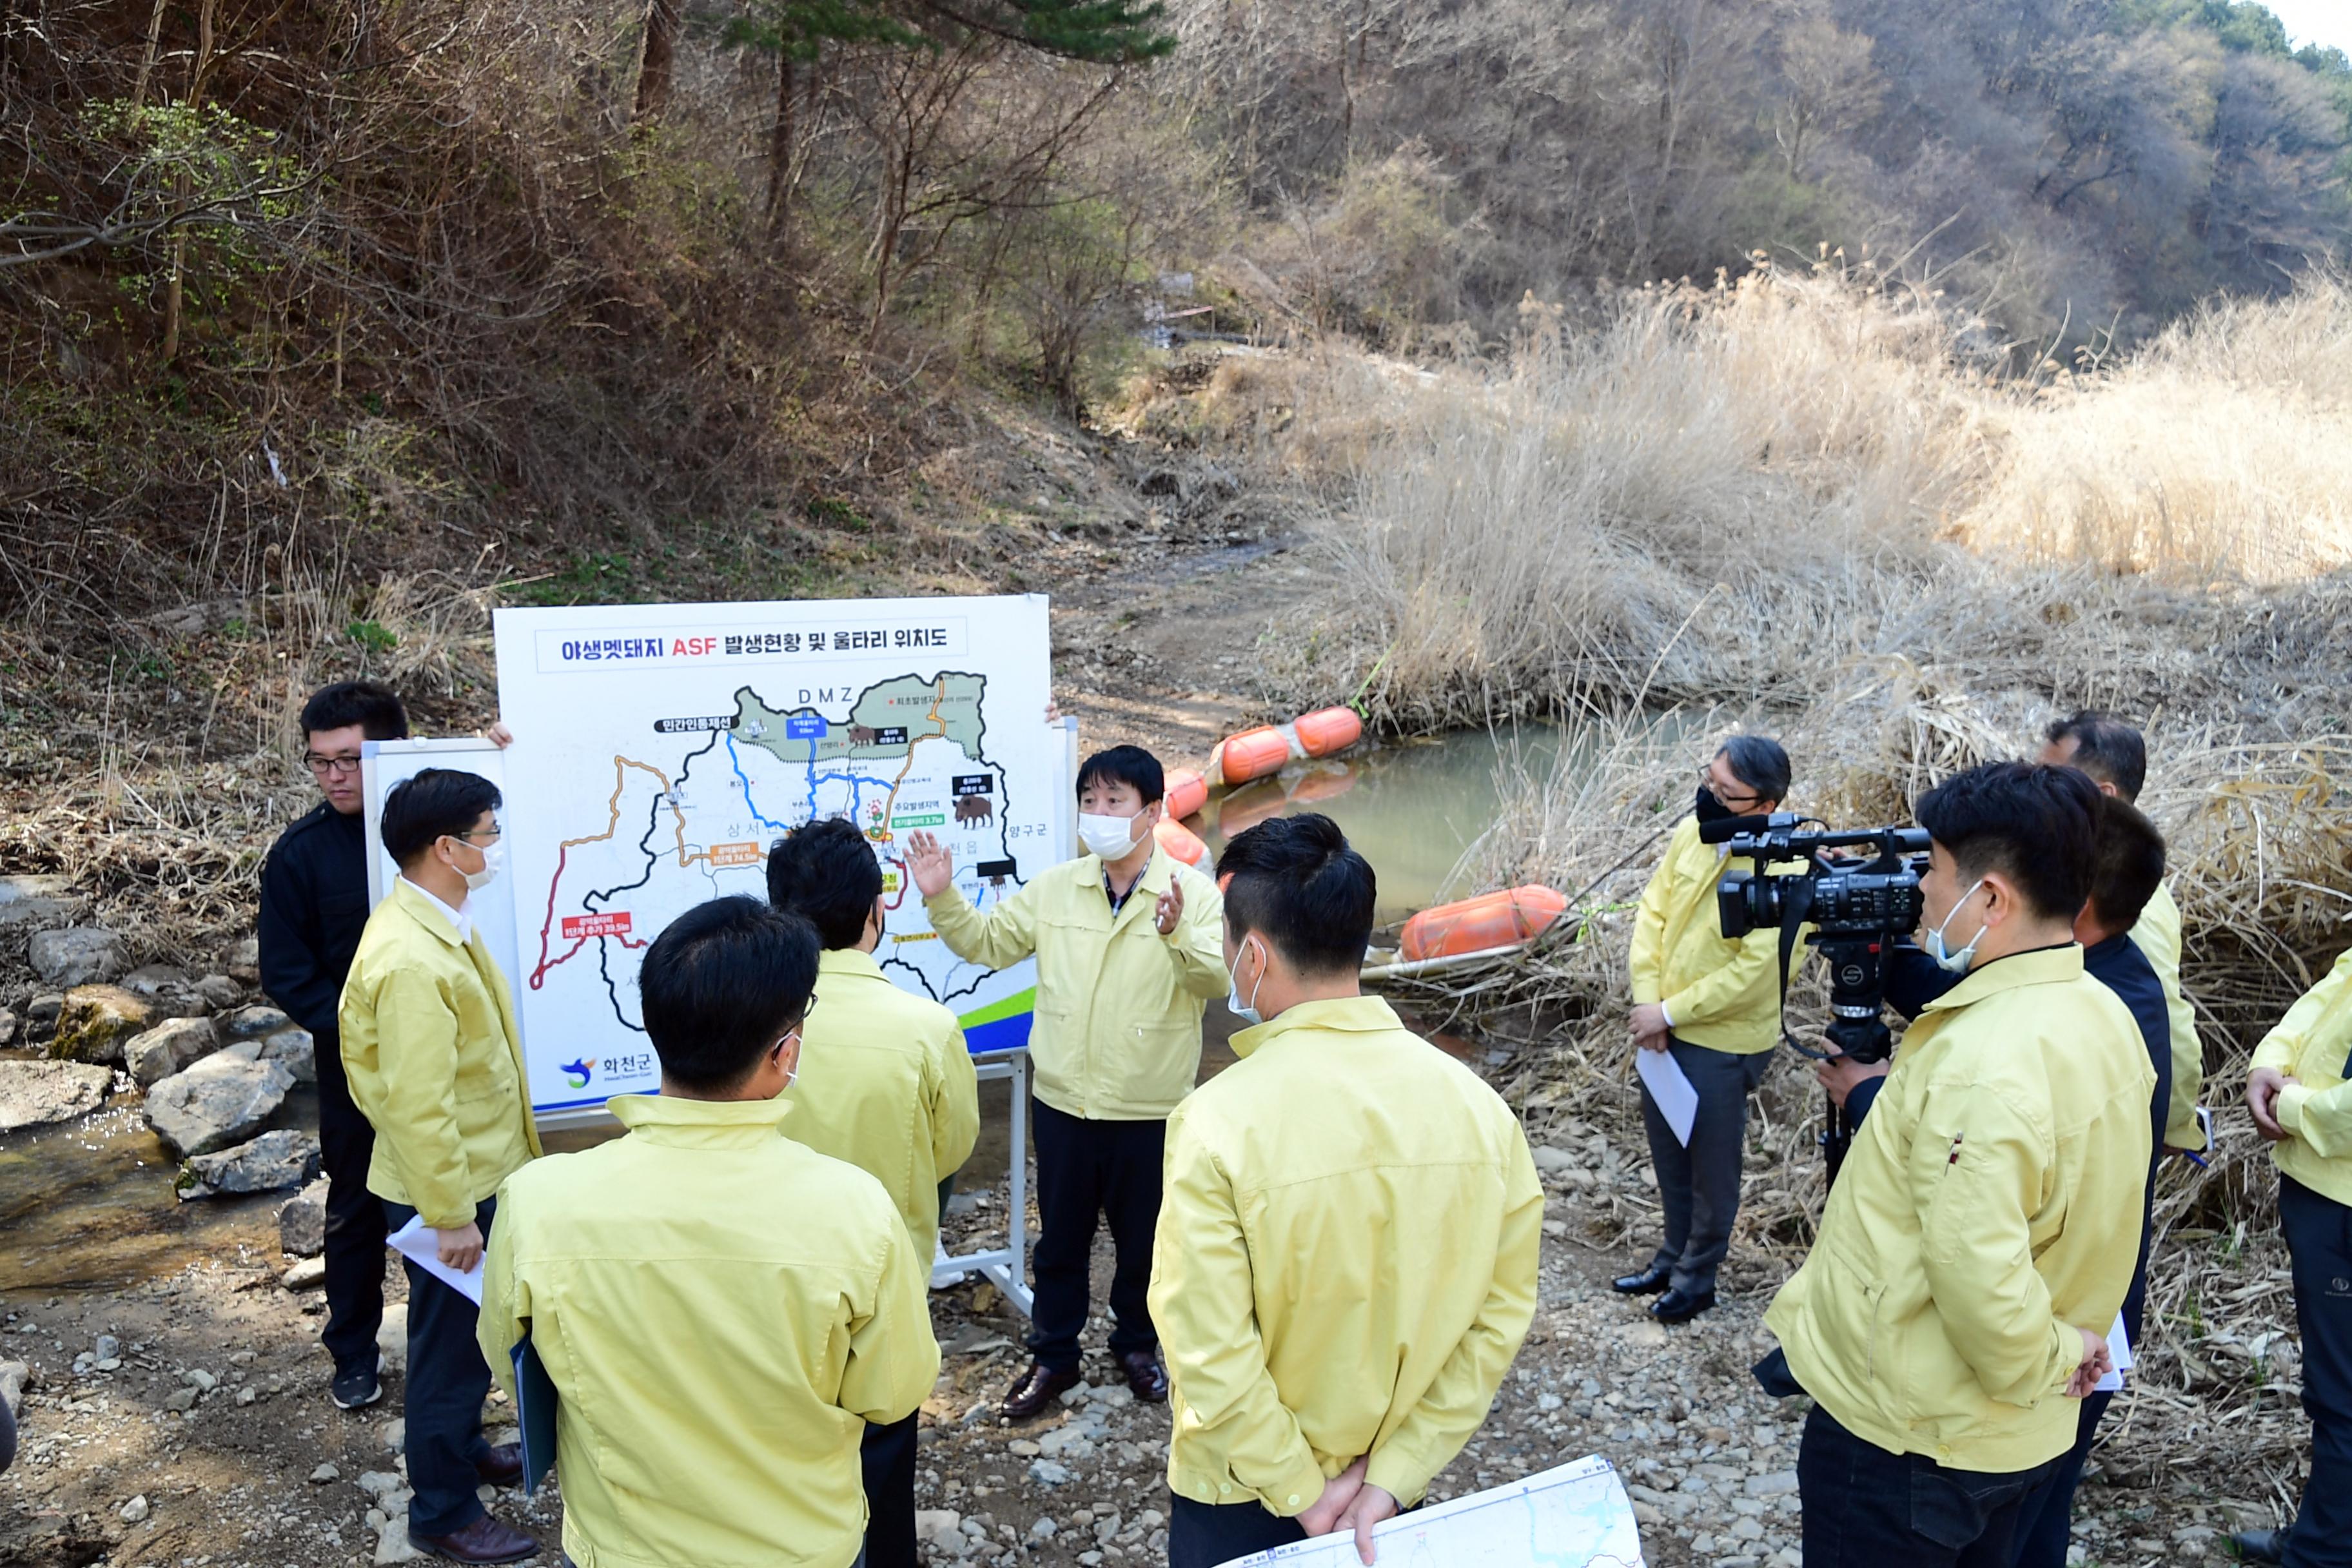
[638, 896, 816, 1093]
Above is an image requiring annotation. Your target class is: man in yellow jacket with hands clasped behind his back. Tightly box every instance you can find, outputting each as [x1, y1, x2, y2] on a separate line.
[1153, 816, 1543, 1568]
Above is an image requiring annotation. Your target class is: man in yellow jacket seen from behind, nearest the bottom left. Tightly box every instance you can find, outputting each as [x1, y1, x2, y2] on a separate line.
[482, 898, 939, 1568]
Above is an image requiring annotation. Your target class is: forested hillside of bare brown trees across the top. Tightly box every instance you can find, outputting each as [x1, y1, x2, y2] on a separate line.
[0, 0, 2352, 634]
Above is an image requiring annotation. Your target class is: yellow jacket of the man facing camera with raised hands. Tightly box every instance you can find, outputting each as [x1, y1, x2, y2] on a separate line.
[922, 848, 1233, 1121]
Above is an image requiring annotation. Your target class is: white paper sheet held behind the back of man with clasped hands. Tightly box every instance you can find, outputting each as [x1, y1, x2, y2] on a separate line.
[1226, 1457, 1654, 1568]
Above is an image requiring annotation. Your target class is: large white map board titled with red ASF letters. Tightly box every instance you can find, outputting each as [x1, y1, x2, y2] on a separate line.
[496, 594, 1068, 1112]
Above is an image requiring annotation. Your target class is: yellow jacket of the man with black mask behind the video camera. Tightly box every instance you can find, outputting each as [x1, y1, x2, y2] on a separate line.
[1630, 818, 1804, 1055]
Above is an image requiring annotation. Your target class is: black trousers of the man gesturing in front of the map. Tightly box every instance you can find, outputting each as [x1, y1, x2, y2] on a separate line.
[1030, 1100, 1169, 1373]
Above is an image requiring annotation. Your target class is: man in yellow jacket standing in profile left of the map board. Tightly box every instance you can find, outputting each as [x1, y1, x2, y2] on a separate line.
[338, 769, 538, 1563]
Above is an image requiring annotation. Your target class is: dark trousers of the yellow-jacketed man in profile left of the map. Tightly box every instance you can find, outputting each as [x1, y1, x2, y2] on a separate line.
[384, 1199, 498, 1535]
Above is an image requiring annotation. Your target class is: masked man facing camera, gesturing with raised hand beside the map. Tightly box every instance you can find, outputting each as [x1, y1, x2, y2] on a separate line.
[908, 745, 1226, 1420]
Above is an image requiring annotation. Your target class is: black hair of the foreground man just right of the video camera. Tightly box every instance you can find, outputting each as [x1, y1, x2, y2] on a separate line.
[1917, 761, 2101, 919]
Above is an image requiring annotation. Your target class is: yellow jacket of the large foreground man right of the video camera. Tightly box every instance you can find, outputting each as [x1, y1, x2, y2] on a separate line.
[1764, 945, 2157, 1474]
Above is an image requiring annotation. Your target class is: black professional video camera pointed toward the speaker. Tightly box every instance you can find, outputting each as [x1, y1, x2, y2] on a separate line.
[1698, 811, 1928, 1182]
